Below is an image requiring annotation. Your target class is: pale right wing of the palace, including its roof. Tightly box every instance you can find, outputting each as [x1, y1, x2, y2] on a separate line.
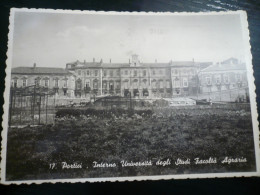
[198, 58, 249, 101]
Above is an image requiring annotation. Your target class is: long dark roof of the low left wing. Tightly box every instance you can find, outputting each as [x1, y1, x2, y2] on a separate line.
[12, 67, 71, 75]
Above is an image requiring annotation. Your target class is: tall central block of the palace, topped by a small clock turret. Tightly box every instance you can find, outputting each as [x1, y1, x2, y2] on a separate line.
[66, 55, 204, 98]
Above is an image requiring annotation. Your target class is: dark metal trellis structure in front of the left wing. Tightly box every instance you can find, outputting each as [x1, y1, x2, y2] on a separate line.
[8, 85, 55, 126]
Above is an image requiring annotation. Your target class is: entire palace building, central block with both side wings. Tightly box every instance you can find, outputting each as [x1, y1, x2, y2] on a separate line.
[12, 55, 248, 101]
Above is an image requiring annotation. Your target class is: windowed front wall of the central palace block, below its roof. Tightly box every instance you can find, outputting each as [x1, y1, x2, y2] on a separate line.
[69, 65, 196, 98]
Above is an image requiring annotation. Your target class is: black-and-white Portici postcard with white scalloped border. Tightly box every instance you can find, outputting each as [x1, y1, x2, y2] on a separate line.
[1, 8, 259, 184]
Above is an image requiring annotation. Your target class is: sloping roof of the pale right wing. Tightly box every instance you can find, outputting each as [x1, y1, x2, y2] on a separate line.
[201, 63, 246, 72]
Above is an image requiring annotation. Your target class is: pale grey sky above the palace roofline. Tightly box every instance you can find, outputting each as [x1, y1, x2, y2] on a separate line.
[12, 11, 244, 68]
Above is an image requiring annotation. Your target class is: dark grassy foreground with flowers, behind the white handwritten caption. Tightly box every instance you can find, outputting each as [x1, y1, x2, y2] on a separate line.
[6, 106, 255, 180]
